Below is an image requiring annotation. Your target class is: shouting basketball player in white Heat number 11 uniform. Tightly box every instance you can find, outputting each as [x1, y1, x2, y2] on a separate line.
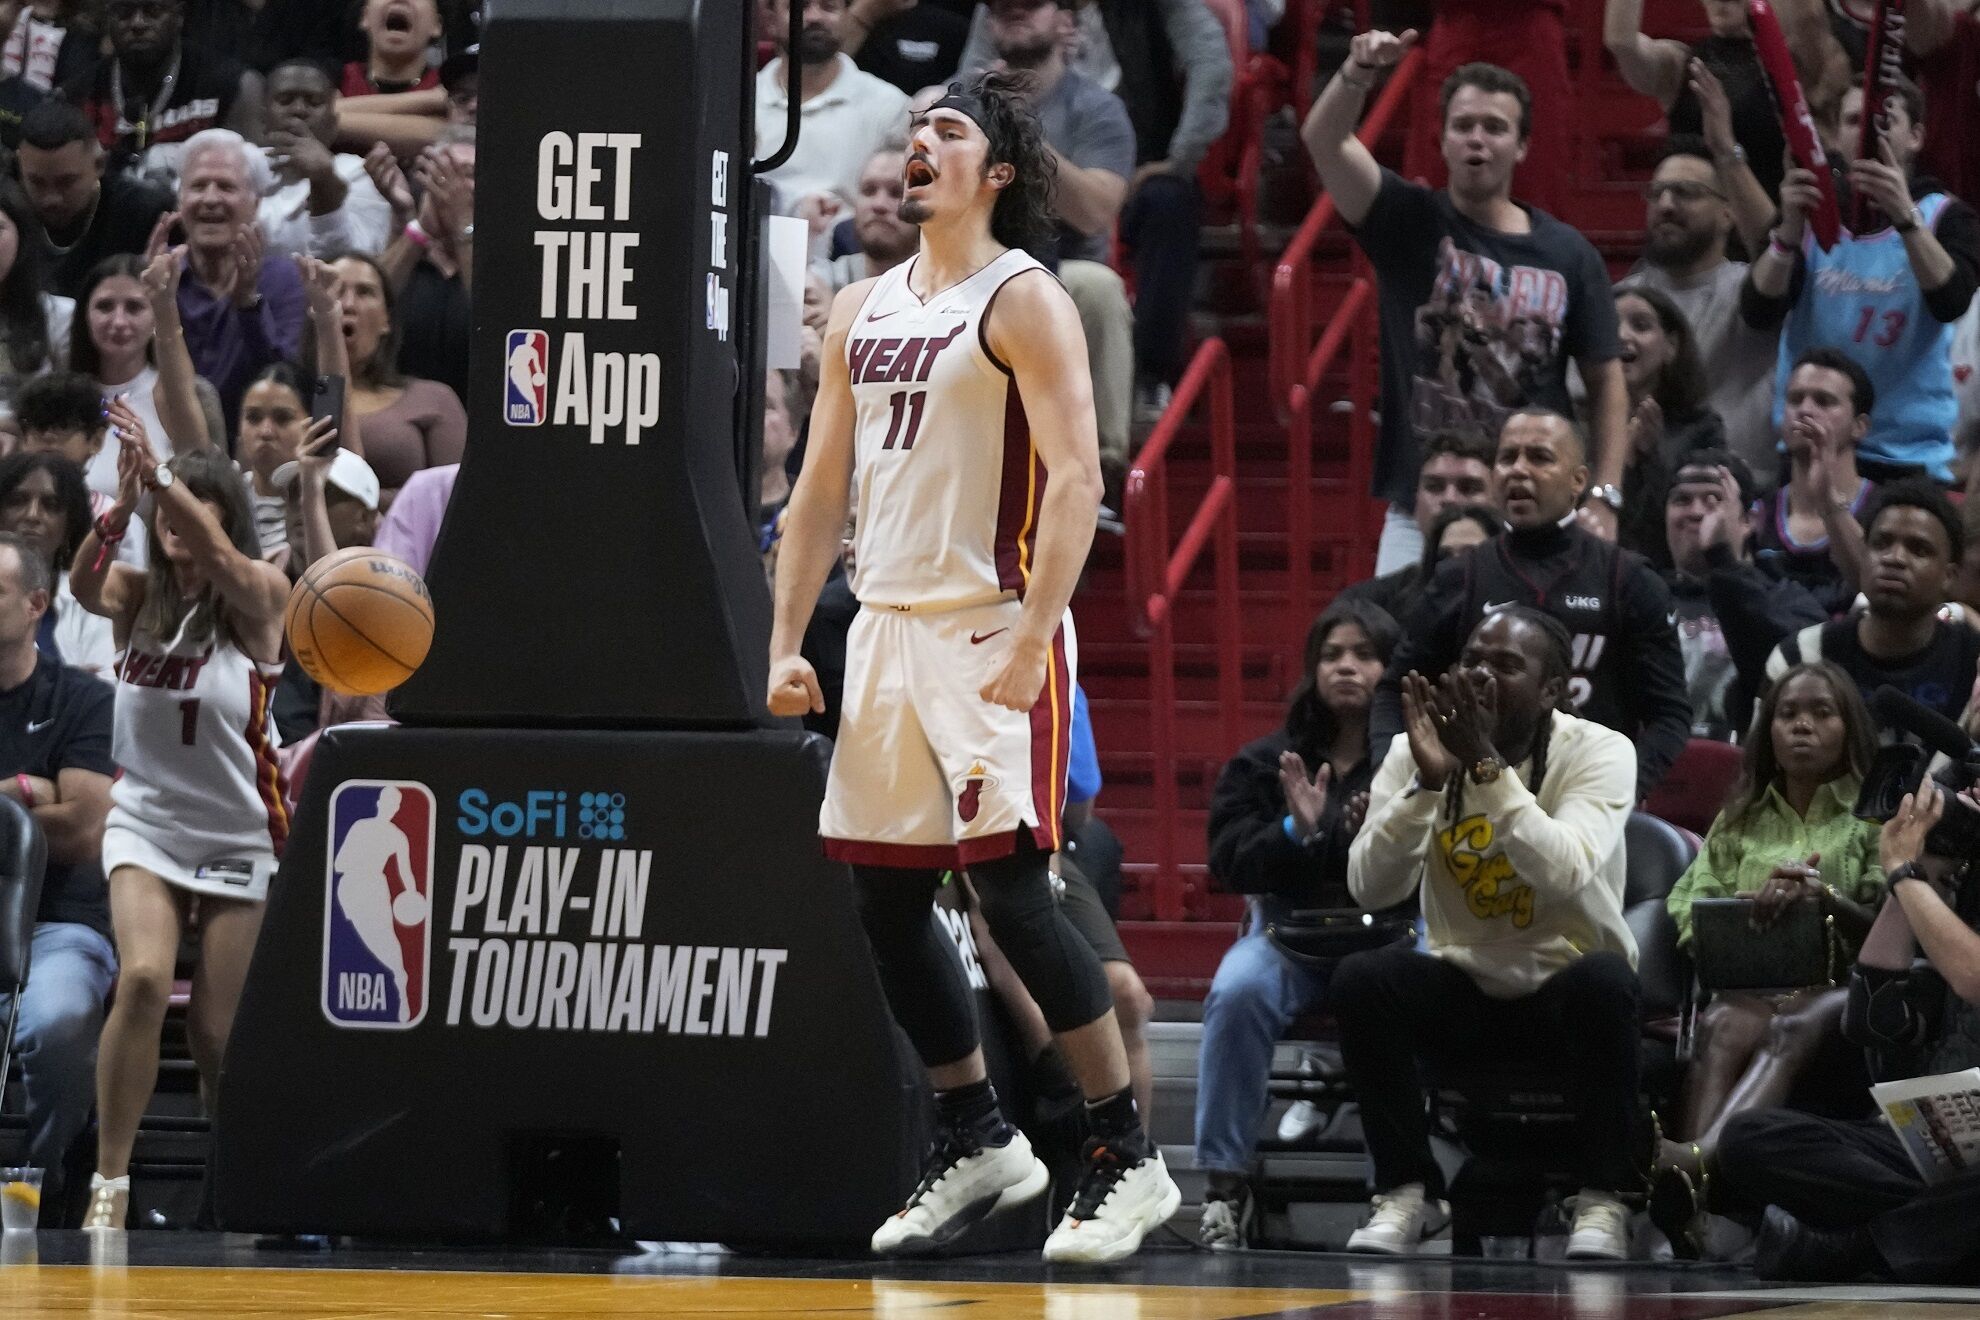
[770, 73, 1180, 1261]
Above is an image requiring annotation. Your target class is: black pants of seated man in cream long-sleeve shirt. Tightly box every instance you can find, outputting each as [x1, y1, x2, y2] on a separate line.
[1329, 946, 1641, 1197]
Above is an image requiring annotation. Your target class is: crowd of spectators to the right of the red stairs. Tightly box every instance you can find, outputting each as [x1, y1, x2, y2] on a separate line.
[1196, 0, 1980, 1280]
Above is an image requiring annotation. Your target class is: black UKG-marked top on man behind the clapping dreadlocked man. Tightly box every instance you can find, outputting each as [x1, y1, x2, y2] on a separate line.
[1368, 524, 1691, 798]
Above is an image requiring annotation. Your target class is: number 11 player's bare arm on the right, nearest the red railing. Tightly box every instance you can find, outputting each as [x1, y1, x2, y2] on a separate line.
[982, 271, 1101, 710]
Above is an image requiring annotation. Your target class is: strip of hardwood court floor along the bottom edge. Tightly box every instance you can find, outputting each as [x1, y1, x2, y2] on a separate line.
[0, 1233, 1980, 1320]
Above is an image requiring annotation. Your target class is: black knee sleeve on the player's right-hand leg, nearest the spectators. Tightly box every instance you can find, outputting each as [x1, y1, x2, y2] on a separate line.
[970, 839, 1113, 1031]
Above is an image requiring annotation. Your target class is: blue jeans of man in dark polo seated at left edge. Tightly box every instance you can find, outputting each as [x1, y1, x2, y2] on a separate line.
[0, 922, 117, 1181]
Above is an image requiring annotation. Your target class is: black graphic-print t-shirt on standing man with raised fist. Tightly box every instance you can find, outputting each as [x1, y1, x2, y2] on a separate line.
[1354, 170, 1622, 509]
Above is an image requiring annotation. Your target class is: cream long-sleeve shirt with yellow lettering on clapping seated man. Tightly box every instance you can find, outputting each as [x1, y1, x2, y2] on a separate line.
[1348, 712, 1635, 999]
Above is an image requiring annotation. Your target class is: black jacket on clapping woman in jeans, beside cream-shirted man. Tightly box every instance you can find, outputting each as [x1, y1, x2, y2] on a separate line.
[1210, 728, 1374, 908]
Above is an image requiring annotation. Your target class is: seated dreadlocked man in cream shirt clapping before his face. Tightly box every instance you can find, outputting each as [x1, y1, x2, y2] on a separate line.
[1331, 606, 1641, 1261]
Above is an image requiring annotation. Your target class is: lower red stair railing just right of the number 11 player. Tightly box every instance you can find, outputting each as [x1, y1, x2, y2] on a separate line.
[1123, 338, 1241, 920]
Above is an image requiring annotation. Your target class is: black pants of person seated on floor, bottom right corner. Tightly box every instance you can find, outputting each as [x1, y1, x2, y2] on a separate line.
[1715, 1108, 1980, 1282]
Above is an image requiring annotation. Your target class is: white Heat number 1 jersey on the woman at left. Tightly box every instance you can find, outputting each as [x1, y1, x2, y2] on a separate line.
[109, 613, 289, 883]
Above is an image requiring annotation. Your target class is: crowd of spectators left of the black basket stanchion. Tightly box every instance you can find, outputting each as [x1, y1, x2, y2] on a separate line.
[0, 0, 479, 1227]
